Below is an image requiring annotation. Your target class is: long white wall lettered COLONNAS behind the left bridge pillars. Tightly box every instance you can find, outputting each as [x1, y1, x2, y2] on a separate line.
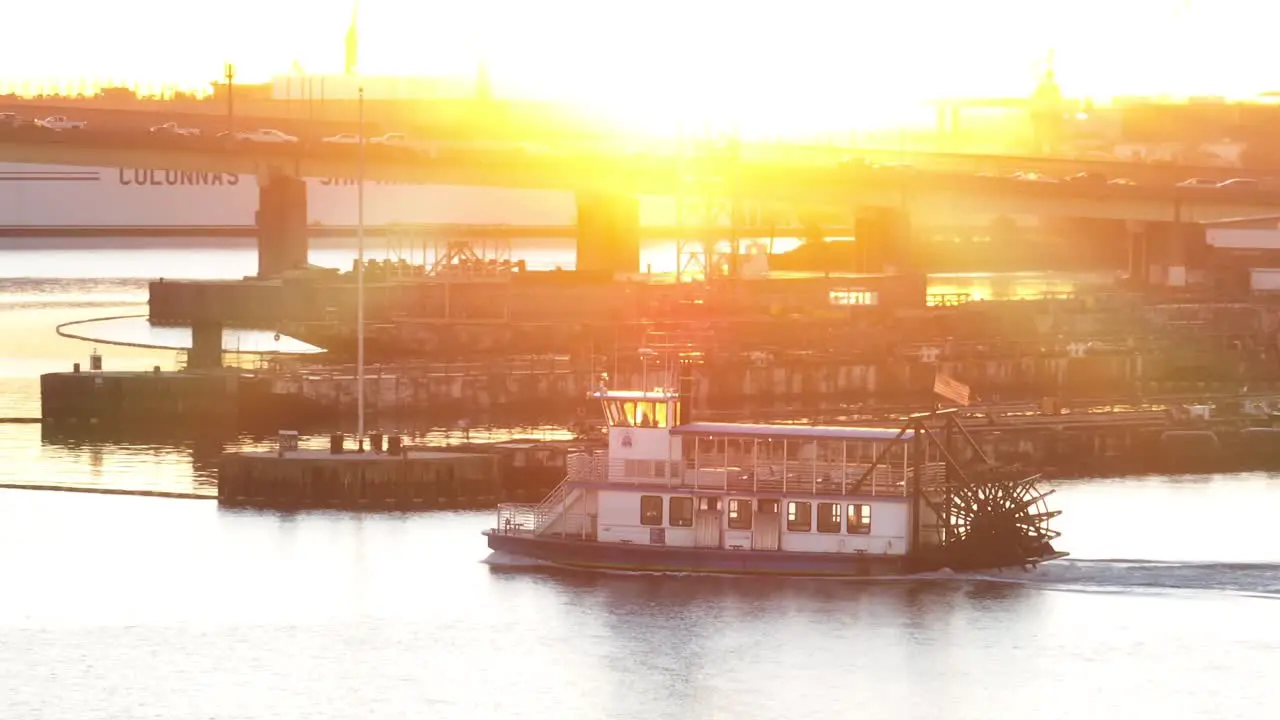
[0, 163, 593, 229]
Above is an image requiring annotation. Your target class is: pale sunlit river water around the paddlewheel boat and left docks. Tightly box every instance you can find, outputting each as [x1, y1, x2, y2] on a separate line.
[0, 242, 1280, 720]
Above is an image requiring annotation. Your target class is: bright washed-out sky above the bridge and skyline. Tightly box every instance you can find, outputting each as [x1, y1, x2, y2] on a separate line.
[0, 0, 1280, 123]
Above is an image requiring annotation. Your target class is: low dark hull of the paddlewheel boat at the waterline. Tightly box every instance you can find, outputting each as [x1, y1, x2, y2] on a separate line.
[485, 530, 1066, 578]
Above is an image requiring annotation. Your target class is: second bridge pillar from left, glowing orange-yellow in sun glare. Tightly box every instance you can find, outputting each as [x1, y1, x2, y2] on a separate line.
[577, 192, 640, 274]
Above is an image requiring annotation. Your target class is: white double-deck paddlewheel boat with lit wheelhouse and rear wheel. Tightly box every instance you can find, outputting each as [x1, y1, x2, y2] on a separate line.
[485, 368, 1066, 577]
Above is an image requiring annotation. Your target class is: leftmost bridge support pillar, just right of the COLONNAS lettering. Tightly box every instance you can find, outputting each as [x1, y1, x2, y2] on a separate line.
[257, 170, 308, 278]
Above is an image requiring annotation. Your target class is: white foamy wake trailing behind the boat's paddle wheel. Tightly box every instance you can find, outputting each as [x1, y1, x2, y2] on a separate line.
[957, 559, 1280, 600]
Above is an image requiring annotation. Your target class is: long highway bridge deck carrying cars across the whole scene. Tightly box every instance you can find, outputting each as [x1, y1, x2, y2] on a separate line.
[0, 131, 1280, 223]
